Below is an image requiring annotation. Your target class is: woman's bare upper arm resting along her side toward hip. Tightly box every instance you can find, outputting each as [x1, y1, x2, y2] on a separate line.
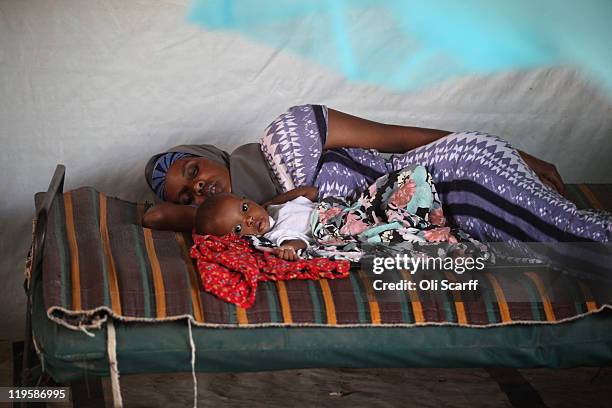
[323, 109, 451, 153]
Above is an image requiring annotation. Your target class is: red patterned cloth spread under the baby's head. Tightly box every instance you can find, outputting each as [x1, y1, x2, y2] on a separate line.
[191, 234, 350, 308]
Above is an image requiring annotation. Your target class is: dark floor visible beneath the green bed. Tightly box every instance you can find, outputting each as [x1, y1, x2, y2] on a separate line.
[0, 341, 612, 408]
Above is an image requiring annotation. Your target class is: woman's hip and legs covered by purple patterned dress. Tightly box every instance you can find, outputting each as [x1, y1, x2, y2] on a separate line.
[389, 132, 612, 242]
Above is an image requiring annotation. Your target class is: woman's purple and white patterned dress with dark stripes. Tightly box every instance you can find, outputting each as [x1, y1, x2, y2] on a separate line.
[261, 105, 612, 242]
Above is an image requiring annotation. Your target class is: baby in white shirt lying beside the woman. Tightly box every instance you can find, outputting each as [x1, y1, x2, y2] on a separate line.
[195, 187, 318, 261]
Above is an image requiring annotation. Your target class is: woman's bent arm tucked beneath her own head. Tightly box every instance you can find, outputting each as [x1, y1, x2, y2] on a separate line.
[142, 202, 197, 232]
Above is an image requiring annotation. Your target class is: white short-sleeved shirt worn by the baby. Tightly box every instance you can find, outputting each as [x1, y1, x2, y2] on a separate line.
[264, 197, 316, 245]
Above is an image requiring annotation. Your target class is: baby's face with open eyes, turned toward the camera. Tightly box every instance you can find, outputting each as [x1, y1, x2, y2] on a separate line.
[211, 194, 270, 236]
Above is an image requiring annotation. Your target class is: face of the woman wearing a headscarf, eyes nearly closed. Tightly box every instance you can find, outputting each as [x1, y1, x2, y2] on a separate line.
[166, 157, 232, 205]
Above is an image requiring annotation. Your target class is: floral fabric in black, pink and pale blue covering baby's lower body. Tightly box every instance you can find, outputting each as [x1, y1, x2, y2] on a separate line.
[311, 165, 489, 258]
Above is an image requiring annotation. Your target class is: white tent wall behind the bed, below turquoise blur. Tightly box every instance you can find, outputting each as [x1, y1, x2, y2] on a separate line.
[0, 0, 612, 340]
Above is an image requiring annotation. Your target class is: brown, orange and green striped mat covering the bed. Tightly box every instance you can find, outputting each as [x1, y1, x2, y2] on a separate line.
[37, 184, 612, 329]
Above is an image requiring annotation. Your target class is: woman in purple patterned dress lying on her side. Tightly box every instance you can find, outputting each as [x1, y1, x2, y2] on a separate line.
[143, 105, 612, 242]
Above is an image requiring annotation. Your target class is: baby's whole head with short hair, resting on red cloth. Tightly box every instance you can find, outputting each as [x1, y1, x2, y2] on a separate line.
[195, 193, 270, 236]
